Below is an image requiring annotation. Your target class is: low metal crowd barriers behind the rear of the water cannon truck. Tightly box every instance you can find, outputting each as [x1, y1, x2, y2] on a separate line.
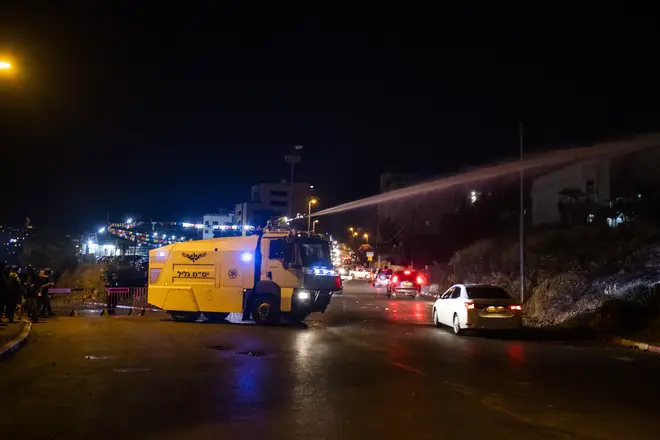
[48, 287, 155, 314]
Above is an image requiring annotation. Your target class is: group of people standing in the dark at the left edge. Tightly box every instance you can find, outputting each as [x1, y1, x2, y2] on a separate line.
[0, 266, 54, 322]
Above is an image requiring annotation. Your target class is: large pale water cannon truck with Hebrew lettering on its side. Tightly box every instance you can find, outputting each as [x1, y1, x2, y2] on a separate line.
[148, 230, 342, 324]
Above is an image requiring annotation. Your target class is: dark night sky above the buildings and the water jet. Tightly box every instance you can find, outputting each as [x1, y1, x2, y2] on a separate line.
[0, 7, 660, 234]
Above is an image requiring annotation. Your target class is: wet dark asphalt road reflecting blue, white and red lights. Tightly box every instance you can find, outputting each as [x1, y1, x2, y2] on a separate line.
[0, 282, 660, 440]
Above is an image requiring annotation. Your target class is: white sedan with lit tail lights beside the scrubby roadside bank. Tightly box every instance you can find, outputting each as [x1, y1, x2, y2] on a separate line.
[433, 284, 522, 335]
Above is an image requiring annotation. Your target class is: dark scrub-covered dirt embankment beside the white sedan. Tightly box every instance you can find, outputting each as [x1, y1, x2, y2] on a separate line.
[431, 224, 660, 333]
